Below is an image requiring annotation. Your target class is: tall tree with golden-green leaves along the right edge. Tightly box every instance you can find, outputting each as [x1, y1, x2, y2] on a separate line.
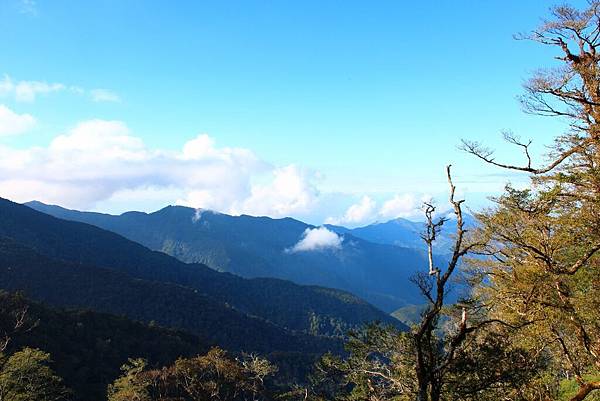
[463, 1, 600, 401]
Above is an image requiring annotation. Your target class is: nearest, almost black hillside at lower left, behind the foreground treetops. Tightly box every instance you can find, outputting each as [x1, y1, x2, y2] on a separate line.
[0, 291, 209, 401]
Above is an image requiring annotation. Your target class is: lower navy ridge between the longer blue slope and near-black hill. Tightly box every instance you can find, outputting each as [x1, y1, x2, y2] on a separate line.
[0, 231, 341, 353]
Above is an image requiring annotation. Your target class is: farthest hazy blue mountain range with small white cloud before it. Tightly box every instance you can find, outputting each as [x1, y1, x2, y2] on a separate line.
[27, 202, 454, 313]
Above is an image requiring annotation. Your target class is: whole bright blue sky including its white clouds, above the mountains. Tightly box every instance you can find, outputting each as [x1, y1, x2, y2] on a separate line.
[0, 0, 583, 225]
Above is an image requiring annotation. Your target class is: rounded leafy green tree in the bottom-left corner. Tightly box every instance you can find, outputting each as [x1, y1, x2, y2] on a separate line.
[0, 348, 70, 401]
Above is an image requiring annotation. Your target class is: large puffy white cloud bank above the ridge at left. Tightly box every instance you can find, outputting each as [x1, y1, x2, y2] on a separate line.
[0, 120, 318, 217]
